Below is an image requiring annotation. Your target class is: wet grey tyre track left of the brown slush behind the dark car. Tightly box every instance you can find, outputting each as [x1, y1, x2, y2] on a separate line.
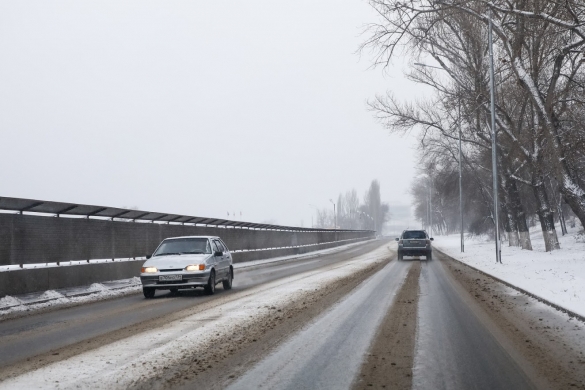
[229, 261, 410, 390]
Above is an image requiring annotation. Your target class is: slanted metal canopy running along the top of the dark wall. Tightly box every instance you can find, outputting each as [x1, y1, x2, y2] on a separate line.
[0, 197, 369, 232]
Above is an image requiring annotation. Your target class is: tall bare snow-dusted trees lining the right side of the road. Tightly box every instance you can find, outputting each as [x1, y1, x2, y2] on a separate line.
[363, 0, 585, 251]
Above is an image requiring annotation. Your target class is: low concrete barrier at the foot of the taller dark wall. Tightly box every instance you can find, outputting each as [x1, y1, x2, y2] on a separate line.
[0, 238, 367, 298]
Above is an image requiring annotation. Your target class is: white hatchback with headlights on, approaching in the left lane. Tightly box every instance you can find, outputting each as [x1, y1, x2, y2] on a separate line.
[140, 236, 234, 298]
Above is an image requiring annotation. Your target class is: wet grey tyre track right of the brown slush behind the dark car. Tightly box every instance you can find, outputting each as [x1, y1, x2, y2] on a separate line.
[413, 260, 534, 390]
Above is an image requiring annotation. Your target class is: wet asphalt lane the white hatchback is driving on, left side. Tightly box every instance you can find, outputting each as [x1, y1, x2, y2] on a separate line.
[0, 241, 381, 368]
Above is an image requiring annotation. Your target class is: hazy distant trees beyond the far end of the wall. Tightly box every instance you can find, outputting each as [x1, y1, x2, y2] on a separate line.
[315, 180, 390, 232]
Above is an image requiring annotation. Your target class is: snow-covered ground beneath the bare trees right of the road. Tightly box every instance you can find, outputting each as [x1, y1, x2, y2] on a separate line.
[433, 226, 585, 316]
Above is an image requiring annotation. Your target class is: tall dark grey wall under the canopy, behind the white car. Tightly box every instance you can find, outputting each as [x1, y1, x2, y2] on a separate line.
[0, 214, 373, 265]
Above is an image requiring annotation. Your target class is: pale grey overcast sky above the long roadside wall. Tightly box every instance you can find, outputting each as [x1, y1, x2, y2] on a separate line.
[0, 0, 416, 226]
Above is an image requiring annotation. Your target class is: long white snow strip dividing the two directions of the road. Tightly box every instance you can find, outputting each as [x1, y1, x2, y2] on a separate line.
[0, 246, 388, 389]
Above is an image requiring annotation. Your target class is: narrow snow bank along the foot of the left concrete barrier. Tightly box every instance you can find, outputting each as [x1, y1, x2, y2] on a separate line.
[0, 241, 368, 319]
